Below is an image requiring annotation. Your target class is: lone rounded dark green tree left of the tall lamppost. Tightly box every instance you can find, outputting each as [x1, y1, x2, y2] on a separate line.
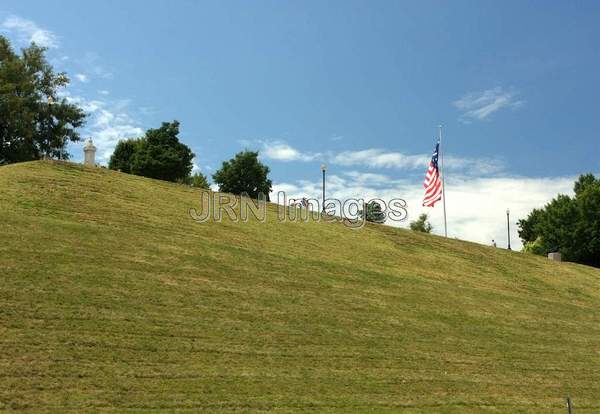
[213, 151, 273, 201]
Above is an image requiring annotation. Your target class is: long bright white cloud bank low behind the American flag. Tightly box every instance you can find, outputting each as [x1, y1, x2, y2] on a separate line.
[271, 172, 576, 250]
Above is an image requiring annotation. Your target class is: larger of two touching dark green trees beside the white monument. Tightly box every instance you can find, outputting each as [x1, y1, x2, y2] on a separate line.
[123, 121, 194, 181]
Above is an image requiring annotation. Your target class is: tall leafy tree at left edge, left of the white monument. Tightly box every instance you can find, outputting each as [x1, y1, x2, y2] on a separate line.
[0, 36, 85, 164]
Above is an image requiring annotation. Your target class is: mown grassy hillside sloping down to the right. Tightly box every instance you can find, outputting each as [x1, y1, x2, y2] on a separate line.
[0, 162, 600, 414]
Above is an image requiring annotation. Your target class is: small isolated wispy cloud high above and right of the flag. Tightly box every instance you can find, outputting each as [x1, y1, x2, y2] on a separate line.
[453, 86, 524, 123]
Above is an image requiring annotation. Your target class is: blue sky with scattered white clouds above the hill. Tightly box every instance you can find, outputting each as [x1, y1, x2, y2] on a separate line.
[0, 0, 600, 247]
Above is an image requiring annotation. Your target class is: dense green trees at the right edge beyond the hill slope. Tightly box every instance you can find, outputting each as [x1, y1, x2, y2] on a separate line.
[517, 174, 600, 267]
